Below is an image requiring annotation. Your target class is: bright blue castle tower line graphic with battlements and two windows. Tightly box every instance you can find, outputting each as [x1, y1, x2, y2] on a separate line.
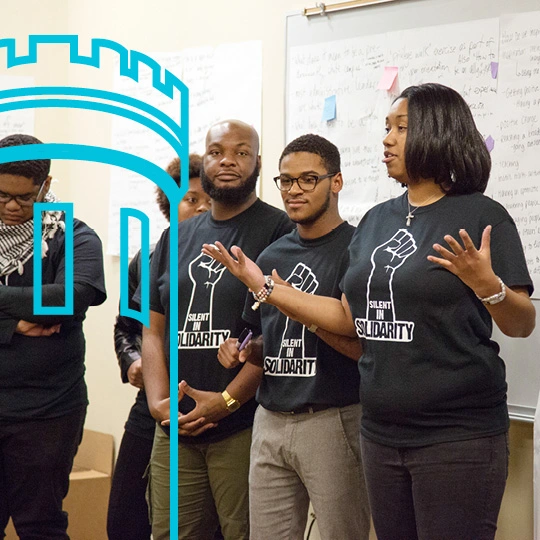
[0, 34, 189, 538]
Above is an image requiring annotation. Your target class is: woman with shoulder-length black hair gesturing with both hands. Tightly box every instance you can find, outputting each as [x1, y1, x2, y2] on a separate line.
[205, 84, 535, 540]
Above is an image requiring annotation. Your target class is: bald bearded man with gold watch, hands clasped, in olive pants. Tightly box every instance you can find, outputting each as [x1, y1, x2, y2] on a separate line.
[142, 120, 293, 540]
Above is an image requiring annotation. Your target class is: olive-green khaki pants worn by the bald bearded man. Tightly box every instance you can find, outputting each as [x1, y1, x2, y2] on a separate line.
[148, 427, 251, 540]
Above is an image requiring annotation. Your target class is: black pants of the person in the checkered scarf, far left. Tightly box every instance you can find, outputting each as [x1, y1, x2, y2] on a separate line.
[0, 407, 86, 540]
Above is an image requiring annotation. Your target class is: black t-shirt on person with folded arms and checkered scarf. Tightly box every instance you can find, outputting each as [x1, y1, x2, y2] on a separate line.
[0, 220, 106, 421]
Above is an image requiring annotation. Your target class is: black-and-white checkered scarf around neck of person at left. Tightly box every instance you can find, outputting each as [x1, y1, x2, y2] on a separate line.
[0, 191, 65, 276]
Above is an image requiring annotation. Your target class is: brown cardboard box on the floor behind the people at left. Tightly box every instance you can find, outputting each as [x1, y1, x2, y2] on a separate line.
[5, 429, 114, 540]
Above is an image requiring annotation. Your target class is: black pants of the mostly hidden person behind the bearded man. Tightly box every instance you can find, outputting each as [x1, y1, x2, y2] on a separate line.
[107, 431, 152, 540]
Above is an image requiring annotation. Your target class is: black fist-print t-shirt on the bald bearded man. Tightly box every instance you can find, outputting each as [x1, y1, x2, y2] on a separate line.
[148, 200, 293, 444]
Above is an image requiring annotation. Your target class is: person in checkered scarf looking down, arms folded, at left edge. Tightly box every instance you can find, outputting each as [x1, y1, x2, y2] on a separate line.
[0, 135, 106, 540]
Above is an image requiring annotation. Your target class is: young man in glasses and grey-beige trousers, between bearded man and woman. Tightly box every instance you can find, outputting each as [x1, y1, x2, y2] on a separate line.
[211, 135, 370, 540]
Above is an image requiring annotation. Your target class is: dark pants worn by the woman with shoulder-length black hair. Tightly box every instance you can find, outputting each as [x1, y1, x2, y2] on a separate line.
[361, 433, 508, 540]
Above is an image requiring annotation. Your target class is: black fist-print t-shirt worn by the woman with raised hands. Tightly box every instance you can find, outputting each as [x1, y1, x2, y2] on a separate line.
[343, 193, 532, 447]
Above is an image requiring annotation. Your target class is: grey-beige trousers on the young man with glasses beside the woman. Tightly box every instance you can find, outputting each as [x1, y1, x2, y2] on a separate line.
[249, 405, 370, 540]
